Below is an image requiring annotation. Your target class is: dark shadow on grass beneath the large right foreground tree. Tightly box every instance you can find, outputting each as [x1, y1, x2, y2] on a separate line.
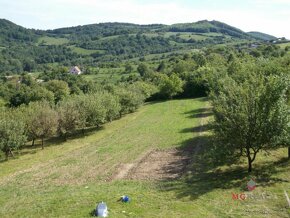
[160, 136, 290, 200]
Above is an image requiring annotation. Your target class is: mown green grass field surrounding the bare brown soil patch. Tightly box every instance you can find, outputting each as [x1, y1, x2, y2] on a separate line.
[0, 98, 290, 218]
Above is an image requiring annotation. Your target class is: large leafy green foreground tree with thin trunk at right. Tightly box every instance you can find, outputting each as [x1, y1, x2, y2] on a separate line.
[211, 72, 289, 172]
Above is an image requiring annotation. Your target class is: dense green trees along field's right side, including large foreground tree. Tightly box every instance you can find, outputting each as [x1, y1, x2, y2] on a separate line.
[132, 46, 290, 172]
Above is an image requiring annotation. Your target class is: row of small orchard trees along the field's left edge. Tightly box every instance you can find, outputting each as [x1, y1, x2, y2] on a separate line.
[0, 82, 156, 159]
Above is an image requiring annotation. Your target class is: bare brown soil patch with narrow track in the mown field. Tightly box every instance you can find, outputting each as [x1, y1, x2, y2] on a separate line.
[111, 105, 208, 180]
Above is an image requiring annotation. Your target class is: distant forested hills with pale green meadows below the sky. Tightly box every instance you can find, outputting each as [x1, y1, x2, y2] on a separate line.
[0, 19, 280, 74]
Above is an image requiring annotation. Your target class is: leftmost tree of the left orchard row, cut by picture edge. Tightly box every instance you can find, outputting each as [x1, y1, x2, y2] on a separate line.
[0, 108, 26, 160]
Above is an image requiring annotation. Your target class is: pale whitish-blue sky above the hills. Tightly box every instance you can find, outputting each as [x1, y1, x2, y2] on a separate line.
[0, 0, 290, 39]
